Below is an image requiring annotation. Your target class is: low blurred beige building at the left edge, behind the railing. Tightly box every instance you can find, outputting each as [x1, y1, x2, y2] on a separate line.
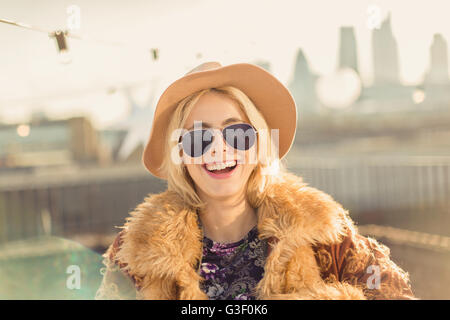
[0, 116, 111, 171]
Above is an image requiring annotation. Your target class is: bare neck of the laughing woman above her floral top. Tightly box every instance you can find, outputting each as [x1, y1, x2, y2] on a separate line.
[200, 193, 257, 243]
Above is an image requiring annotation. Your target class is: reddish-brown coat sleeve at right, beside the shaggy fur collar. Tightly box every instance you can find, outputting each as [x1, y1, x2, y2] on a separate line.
[316, 232, 416, 300]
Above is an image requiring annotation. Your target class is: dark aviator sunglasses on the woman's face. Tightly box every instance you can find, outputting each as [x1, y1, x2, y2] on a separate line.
[178, 123, 258, 158]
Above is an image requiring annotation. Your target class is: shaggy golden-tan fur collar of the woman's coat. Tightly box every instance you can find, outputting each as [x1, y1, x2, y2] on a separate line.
[117, 173, 353, 299]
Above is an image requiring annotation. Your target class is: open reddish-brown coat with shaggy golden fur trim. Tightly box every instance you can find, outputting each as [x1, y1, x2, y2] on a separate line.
[96, 173, 415, 300]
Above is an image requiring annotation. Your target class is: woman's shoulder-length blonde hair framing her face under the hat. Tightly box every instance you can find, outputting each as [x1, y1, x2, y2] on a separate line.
[161, 86, 286, 208]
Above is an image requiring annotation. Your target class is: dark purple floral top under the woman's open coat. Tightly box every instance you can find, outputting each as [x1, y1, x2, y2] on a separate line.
[200, 226, 267, 300]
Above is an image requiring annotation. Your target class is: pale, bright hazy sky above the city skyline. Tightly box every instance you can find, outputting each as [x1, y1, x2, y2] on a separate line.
[0, 0, 450, 128]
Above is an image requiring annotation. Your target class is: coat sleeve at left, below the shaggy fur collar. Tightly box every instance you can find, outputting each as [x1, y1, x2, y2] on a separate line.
[95, 231, 142, 300]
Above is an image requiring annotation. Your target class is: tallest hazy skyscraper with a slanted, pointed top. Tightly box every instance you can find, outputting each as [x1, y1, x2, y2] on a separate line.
[372, 14, 399, 85]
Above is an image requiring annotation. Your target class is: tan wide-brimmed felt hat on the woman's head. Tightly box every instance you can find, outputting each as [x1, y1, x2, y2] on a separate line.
[142, 61, 297, 179]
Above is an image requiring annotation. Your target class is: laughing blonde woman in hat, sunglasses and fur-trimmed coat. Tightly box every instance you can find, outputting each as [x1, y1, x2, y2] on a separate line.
[97, 62, 414, 300]
